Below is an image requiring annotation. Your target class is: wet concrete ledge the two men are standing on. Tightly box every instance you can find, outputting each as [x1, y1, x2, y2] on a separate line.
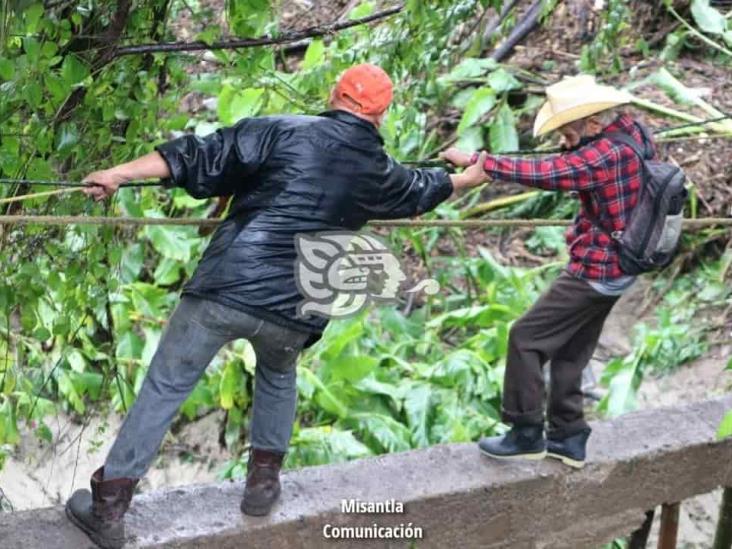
[0, 395, 732, 549]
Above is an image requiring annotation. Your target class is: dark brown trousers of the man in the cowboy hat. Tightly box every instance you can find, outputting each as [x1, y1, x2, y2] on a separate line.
[502, 272, 618, 438]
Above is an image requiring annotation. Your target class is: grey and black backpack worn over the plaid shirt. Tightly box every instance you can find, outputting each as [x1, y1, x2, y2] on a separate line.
[590, 124, 687, 275]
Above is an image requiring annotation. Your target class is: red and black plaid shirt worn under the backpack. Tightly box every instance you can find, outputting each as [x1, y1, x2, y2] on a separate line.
[485, 115, 643, 281]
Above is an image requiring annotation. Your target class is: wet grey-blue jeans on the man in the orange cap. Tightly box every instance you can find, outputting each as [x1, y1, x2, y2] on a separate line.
[104, 296, 308, 480]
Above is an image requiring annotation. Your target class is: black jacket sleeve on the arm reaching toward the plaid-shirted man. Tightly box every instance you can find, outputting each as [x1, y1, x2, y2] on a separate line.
[369, 157, 453, 219]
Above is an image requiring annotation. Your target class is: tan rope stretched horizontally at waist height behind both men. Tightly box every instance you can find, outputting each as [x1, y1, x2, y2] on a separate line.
[0, 215, 732, 229]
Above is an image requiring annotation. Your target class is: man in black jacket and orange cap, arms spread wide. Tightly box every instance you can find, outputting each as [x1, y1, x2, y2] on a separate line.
[66, 65, 487, 547]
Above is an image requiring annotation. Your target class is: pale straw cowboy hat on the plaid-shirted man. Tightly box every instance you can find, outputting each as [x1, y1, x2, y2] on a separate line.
[534, 74, 633, 137]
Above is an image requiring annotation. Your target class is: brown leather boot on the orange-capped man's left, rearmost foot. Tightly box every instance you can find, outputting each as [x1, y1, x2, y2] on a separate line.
[66, 467, 139, 549]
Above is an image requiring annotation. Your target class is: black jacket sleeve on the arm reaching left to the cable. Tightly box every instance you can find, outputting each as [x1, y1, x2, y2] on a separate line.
[155, 118, 274, 198]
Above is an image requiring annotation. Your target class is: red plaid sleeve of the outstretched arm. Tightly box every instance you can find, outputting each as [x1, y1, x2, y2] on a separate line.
[473, 140, 616, 191]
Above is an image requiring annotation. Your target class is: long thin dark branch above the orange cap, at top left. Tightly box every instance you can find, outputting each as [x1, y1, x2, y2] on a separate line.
[113, 5, 404, 57]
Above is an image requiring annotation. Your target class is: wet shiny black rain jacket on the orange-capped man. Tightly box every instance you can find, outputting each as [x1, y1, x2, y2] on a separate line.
[156, 111, 453, 344]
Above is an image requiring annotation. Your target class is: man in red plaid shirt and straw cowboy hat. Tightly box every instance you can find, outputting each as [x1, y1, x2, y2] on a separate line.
[442, 76, 652, 467]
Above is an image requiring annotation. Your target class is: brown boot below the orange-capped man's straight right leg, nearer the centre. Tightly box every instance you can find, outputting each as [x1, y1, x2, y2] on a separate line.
[241, 448, 285, 517]
